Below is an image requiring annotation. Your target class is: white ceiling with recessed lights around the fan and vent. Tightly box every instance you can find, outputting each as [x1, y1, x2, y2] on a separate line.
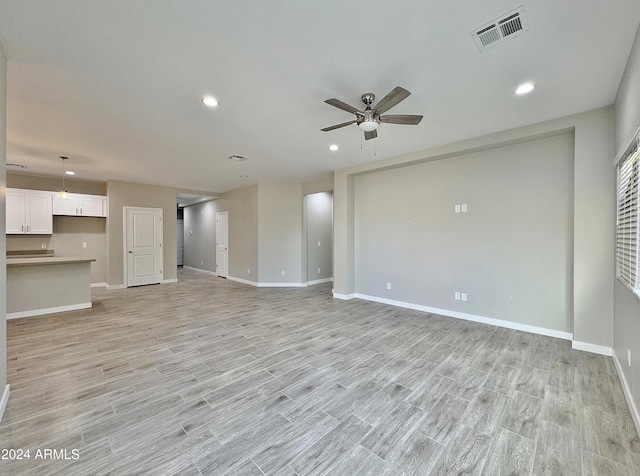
[0, 0, 640, 192]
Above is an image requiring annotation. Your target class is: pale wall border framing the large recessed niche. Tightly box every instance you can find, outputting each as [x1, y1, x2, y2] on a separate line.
[333, 107, 615, 353]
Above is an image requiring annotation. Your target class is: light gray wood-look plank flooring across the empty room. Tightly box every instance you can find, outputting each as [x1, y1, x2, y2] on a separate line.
[0, 270, 640, 476]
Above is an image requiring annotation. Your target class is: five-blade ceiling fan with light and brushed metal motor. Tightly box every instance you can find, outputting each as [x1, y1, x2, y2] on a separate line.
[320, 86, 422, 140]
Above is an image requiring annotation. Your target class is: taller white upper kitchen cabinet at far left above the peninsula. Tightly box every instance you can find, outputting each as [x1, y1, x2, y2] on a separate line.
[6, 188, 53, 235]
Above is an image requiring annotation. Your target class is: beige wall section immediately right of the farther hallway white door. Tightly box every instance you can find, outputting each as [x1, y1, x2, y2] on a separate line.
[216, 184, 259, 283]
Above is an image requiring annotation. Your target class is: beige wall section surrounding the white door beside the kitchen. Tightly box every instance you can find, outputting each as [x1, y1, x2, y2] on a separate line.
[107, 181, 177, 286]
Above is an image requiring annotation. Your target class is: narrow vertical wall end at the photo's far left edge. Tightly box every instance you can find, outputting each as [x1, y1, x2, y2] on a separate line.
[0, 37, 7, 406]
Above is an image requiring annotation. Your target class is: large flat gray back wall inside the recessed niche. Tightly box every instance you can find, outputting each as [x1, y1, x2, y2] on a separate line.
[355, 134, 573, 333]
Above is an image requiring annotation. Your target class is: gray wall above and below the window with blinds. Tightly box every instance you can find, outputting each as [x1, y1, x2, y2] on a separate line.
[612, 23, 640, 431]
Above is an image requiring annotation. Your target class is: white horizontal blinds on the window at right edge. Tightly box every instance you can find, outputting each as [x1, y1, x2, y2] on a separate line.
[616, 141, 640, 293]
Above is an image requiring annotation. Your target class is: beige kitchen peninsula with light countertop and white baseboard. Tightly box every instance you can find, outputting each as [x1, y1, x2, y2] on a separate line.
[7, 252, 95, 319]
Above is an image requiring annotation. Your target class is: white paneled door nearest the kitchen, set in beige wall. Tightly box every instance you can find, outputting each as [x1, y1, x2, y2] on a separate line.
[124, 207, 163, 286]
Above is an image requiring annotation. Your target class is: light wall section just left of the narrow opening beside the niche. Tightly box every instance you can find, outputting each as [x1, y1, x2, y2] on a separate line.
[258, 182, 307, 286]
